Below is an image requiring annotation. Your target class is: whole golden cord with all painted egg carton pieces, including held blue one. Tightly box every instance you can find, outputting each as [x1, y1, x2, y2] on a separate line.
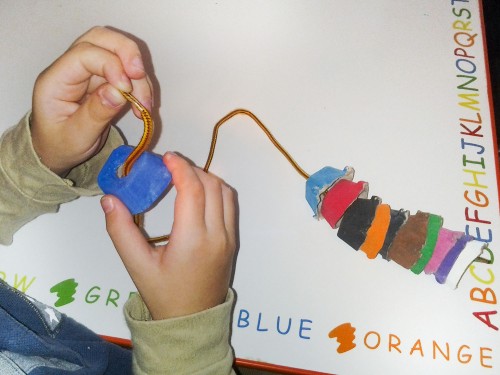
[98, 98, 493, 288]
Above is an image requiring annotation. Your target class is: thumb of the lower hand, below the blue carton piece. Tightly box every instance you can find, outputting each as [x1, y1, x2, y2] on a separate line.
[101, 195, 152, 277]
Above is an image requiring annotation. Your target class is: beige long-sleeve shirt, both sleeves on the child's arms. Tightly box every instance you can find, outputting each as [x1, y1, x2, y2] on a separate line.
[0, 114, 234, 375]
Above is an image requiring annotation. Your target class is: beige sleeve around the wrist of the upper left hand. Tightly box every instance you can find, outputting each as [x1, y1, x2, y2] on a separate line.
[0, 113, 123, 245]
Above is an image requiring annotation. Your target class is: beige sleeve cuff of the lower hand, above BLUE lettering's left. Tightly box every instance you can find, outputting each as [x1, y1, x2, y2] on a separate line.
[125, 289, 235, 375]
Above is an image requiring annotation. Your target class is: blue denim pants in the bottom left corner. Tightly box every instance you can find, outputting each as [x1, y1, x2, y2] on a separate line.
[0, 280, 132, 375]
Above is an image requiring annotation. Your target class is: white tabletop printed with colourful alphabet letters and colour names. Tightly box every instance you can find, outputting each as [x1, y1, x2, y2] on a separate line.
[0, 0, 500, 375]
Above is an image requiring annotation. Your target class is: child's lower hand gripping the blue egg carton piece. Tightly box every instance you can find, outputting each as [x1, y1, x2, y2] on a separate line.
[101, 154, 236, 320]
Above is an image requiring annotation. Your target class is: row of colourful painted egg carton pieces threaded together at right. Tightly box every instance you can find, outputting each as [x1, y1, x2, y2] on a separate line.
[306, 166, 488, 289]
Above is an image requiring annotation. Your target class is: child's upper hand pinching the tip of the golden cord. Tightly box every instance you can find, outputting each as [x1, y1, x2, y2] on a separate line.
[31, 27, 152, 176]
